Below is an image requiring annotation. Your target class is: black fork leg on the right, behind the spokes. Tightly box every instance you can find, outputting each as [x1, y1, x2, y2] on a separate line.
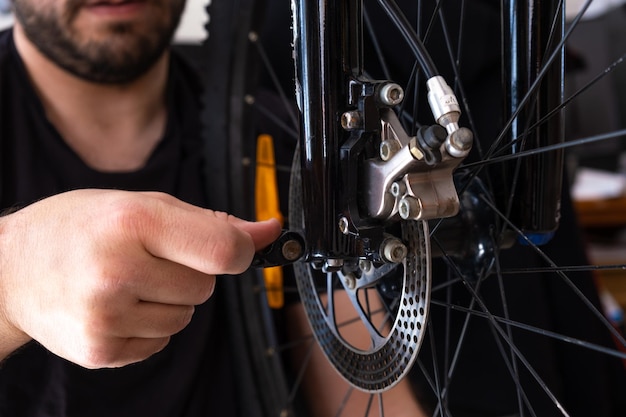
[502, 0, 564, 244]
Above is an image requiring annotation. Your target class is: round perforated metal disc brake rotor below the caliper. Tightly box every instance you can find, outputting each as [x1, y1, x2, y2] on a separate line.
[295, 221, 430, 392]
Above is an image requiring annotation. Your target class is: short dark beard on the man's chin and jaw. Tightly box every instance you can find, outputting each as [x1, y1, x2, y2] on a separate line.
[13, 0, 185, 84]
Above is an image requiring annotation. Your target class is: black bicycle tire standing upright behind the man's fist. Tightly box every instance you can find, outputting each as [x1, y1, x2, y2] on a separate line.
[201, 0, 290, 417]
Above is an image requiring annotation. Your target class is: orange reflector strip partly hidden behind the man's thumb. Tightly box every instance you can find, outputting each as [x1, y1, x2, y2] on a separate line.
[254, 135, 285, 308]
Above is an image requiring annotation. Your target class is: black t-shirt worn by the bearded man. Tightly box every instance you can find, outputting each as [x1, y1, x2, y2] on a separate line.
[0, 31, 235, 417]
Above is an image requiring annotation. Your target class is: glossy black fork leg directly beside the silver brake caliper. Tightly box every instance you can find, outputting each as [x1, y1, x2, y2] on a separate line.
[292, 0, 361, 269]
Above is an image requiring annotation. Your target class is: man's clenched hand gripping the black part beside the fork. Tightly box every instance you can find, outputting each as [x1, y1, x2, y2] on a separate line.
[0, 190, 280, 368]
